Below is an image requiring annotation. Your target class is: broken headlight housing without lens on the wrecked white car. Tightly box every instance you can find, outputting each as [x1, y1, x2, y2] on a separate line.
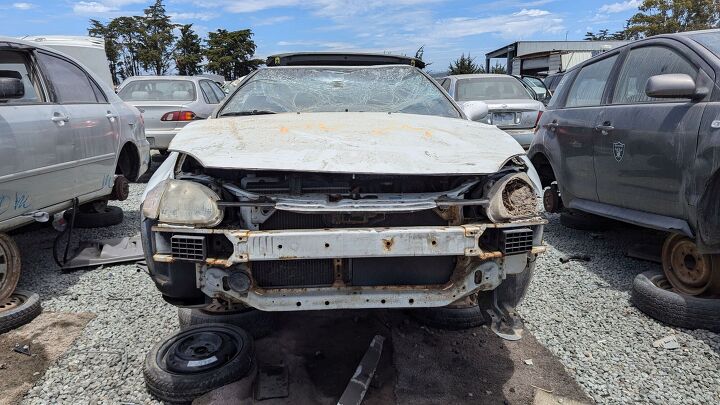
[485, 173, 538, 222]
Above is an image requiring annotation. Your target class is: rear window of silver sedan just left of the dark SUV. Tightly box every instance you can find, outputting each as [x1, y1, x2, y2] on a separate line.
[457, 77, 532, 101]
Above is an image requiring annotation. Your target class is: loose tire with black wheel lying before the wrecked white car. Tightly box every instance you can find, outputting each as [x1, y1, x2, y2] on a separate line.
[143, 324, 255, 404]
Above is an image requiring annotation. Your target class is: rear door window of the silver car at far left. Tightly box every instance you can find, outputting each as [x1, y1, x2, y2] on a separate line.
[38, 53, 98, 104]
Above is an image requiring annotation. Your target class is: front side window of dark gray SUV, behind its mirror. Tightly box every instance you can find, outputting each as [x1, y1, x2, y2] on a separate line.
[612, 46, 698, 104]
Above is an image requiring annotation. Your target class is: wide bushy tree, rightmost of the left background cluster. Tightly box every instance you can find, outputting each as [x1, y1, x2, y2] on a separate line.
[205, 29, 263, 80]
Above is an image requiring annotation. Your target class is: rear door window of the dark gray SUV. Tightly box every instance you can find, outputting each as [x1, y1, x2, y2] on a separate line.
[565, 55, 617, 107]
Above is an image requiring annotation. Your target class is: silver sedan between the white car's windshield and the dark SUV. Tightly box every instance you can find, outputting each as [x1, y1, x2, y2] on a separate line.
[439, 74, 545, 150]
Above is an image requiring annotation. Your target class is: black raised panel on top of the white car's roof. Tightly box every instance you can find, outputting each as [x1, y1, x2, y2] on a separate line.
[265, 52, 425, 69]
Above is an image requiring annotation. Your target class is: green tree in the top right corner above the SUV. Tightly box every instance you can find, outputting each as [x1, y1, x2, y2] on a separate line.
[625, 0, 720, 38]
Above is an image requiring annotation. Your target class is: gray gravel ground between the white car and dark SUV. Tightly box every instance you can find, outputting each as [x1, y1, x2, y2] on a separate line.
[518, 215, 720, 404]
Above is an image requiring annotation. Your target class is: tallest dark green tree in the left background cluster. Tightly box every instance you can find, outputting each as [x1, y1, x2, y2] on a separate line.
[138, 0, 175, 75]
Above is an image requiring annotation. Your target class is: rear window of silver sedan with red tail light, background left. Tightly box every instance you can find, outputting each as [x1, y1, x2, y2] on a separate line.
[118, 80, 197, 101]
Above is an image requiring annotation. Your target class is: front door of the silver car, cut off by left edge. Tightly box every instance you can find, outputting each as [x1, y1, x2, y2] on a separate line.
[0, 48, 74, 221]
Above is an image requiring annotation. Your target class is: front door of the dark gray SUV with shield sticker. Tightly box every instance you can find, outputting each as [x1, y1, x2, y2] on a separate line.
[595, 40, 714, 218]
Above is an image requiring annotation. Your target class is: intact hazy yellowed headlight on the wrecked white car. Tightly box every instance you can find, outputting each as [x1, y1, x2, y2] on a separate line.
[143, 179, 223, 227]
